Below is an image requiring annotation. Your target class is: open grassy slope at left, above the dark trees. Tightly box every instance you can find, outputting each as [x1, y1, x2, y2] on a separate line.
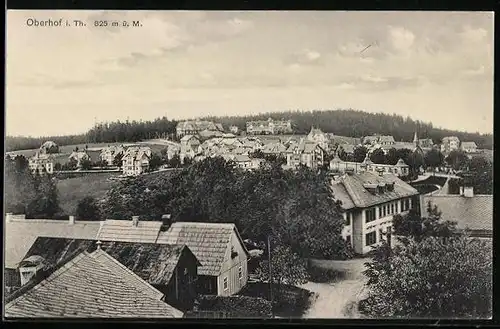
[57, 173, 117, 215]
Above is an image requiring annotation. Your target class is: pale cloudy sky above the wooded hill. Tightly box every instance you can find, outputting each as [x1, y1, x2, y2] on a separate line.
[6, 10, 494, 136]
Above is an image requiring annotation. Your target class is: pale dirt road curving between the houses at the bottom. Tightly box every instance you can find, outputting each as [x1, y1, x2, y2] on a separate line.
[301, 258, 369, 318]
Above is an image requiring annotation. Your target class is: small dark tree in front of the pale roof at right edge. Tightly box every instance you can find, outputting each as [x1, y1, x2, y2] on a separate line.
[393, 202, 458, 241]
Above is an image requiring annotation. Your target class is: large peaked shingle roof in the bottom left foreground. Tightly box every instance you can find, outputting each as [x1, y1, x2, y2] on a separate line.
[5, 249, 183, 319]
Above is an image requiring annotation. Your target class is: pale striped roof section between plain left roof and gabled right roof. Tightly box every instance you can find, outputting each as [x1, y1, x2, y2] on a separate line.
[97, 219, 162, 243]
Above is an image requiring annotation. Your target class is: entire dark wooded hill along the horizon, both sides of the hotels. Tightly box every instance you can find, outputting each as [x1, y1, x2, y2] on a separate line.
[5, 110, 493, 152]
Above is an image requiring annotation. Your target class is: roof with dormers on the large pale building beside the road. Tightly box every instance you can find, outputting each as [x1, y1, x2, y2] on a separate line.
[331, 171, 418, 210]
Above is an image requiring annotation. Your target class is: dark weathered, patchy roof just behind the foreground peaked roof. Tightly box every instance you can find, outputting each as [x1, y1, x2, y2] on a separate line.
[25, 238, 199, 285]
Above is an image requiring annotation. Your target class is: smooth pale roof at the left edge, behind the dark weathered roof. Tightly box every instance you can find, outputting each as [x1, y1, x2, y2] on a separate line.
[4, 213, 101, 292]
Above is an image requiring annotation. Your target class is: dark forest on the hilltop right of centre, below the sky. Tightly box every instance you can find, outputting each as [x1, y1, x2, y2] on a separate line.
[204, 109, 493, 149]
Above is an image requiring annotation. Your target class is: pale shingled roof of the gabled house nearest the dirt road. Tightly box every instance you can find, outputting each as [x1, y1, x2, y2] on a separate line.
[157, 222, 248, 276]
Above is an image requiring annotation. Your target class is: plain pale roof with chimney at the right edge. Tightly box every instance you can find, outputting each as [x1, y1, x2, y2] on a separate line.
[420, 186, 493, 239]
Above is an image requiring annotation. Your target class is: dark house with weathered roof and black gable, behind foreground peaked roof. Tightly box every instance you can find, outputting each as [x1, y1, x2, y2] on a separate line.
[20, 237, 201, 309]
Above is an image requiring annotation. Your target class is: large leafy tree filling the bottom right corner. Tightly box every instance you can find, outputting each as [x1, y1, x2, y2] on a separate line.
[359, 235, 493, 319]
